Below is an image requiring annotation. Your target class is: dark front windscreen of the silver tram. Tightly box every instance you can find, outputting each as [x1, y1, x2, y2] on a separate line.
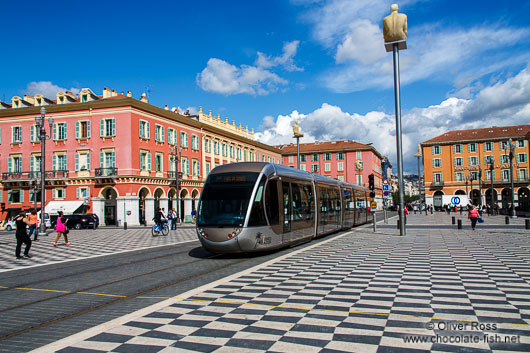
[197, 173, 259, 227]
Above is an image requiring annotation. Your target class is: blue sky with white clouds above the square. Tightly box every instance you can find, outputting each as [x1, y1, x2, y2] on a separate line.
[0, 0, 530, 174]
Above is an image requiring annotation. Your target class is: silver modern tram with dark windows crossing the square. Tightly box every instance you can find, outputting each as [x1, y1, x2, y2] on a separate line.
[196, 162, 369, 253]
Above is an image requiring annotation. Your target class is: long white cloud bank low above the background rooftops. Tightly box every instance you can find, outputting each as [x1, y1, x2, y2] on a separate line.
[256, 65, 530, 173]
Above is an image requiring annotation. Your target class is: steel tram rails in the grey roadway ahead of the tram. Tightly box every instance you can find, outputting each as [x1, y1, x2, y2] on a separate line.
[0, 245, 251, 341]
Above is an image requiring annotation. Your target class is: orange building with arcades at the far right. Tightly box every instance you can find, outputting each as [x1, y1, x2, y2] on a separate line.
[421, 125, 530, 211]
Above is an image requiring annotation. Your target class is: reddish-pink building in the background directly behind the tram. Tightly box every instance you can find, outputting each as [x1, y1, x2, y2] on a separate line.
[276, 140, 391, 207]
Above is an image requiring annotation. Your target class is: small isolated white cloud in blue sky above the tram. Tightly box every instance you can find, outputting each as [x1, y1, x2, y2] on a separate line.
[197, 40, 303, 95]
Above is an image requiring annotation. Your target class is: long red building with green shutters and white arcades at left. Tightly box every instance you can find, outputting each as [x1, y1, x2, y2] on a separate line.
[0, 88, 281, 225]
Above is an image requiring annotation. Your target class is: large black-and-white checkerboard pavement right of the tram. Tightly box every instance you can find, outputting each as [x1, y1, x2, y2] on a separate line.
[34, 214, 530, 353]
